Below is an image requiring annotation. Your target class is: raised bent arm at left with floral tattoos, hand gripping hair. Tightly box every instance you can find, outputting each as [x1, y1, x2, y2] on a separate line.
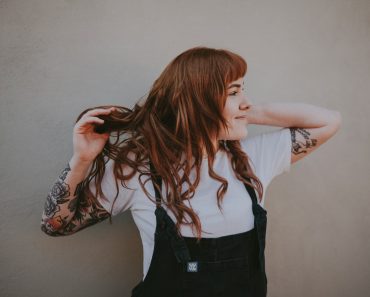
[41, 108, 114, 236]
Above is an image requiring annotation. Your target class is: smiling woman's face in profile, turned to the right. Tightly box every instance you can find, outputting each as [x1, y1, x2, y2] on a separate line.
[218, 77, 251, 140]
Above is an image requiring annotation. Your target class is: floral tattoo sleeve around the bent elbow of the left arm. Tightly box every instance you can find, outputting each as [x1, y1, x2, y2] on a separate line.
[41, 164, 109, 236]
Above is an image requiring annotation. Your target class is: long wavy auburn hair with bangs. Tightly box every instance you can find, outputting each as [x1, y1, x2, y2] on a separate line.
[76, 47, 263, 239]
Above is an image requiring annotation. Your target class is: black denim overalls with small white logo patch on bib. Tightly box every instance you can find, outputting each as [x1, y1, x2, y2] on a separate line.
[132, 164, 267, 297]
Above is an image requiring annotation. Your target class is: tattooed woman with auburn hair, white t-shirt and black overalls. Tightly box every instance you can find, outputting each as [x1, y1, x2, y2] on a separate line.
[41, 47, 341, 297]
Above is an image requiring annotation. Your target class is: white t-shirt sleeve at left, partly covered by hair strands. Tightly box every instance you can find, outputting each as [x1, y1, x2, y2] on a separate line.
[89, 159, 135, 216]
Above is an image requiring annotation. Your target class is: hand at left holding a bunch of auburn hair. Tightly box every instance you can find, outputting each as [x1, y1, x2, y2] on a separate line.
[73, 107, 115, 162]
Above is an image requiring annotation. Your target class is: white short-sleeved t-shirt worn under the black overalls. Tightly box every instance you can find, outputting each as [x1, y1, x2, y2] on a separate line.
[90, 128, 291, 277]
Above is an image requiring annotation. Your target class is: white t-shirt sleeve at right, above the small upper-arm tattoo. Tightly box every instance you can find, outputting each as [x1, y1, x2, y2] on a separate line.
[241, 128, 292, 186]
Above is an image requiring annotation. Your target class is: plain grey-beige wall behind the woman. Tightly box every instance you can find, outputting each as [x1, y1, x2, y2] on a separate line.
[0, 0, 370, 297]
